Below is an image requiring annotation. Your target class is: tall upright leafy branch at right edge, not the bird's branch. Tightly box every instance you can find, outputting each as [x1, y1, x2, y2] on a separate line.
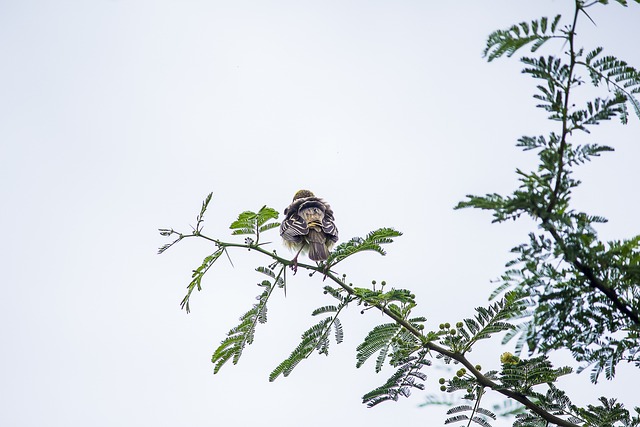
[457, 2, 640, 394]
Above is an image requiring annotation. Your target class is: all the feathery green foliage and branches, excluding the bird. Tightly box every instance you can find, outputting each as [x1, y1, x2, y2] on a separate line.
[159, 0, 640, 427]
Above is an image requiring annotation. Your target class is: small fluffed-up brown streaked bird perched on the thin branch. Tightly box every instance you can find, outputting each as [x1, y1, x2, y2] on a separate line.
[280, 190, 338, 272]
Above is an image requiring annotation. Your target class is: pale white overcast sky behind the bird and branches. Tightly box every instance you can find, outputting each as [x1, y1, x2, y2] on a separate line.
[0, 0, 640, 427]
